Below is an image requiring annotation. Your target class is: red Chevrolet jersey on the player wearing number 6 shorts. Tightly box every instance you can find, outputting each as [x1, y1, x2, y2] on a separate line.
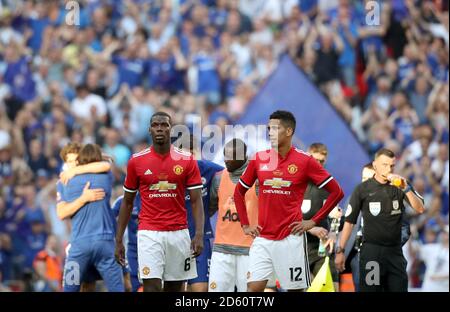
[123, 146, 202, 231]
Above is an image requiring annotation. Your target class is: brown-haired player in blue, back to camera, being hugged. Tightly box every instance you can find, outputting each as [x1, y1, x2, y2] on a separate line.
[59, 144, 124, 292]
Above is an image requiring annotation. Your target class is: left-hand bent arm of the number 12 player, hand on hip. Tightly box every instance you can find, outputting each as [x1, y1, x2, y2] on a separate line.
[233, 160, 260, 237]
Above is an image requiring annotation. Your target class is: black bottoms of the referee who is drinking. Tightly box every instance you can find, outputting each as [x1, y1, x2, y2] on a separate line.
[359, 242, 408, 292]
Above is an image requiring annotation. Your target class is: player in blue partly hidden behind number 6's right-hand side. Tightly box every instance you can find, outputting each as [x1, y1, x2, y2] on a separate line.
[186, 135, 224, 292]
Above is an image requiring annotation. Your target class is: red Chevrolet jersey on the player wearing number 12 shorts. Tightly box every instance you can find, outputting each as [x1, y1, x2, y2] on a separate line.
[239, 147, 333, 240]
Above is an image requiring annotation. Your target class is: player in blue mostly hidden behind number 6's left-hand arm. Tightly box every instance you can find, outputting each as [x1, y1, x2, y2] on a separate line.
[112, 193, 141, 292]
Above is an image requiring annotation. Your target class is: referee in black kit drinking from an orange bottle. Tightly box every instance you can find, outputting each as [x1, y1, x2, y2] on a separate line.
[336, 148, 425, 292]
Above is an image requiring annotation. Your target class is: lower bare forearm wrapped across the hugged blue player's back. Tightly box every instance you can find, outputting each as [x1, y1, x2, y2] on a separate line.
[56, 182, 105, 220]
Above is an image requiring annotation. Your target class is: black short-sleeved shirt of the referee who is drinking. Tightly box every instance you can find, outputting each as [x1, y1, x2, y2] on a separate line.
[345, 178, 407, 246]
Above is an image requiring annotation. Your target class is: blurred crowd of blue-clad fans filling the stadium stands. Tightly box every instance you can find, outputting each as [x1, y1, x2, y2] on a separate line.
[0, 0, 449, 291]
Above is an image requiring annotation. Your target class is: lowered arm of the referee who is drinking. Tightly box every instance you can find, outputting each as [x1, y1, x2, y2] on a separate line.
[334, 184, 361, 272]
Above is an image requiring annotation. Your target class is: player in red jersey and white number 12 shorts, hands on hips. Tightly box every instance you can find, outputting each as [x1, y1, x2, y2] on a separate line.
[234, 111, 344, 291]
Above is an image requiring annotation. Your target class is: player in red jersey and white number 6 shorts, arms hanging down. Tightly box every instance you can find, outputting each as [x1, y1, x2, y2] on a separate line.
[116, 112, 204, 291]
